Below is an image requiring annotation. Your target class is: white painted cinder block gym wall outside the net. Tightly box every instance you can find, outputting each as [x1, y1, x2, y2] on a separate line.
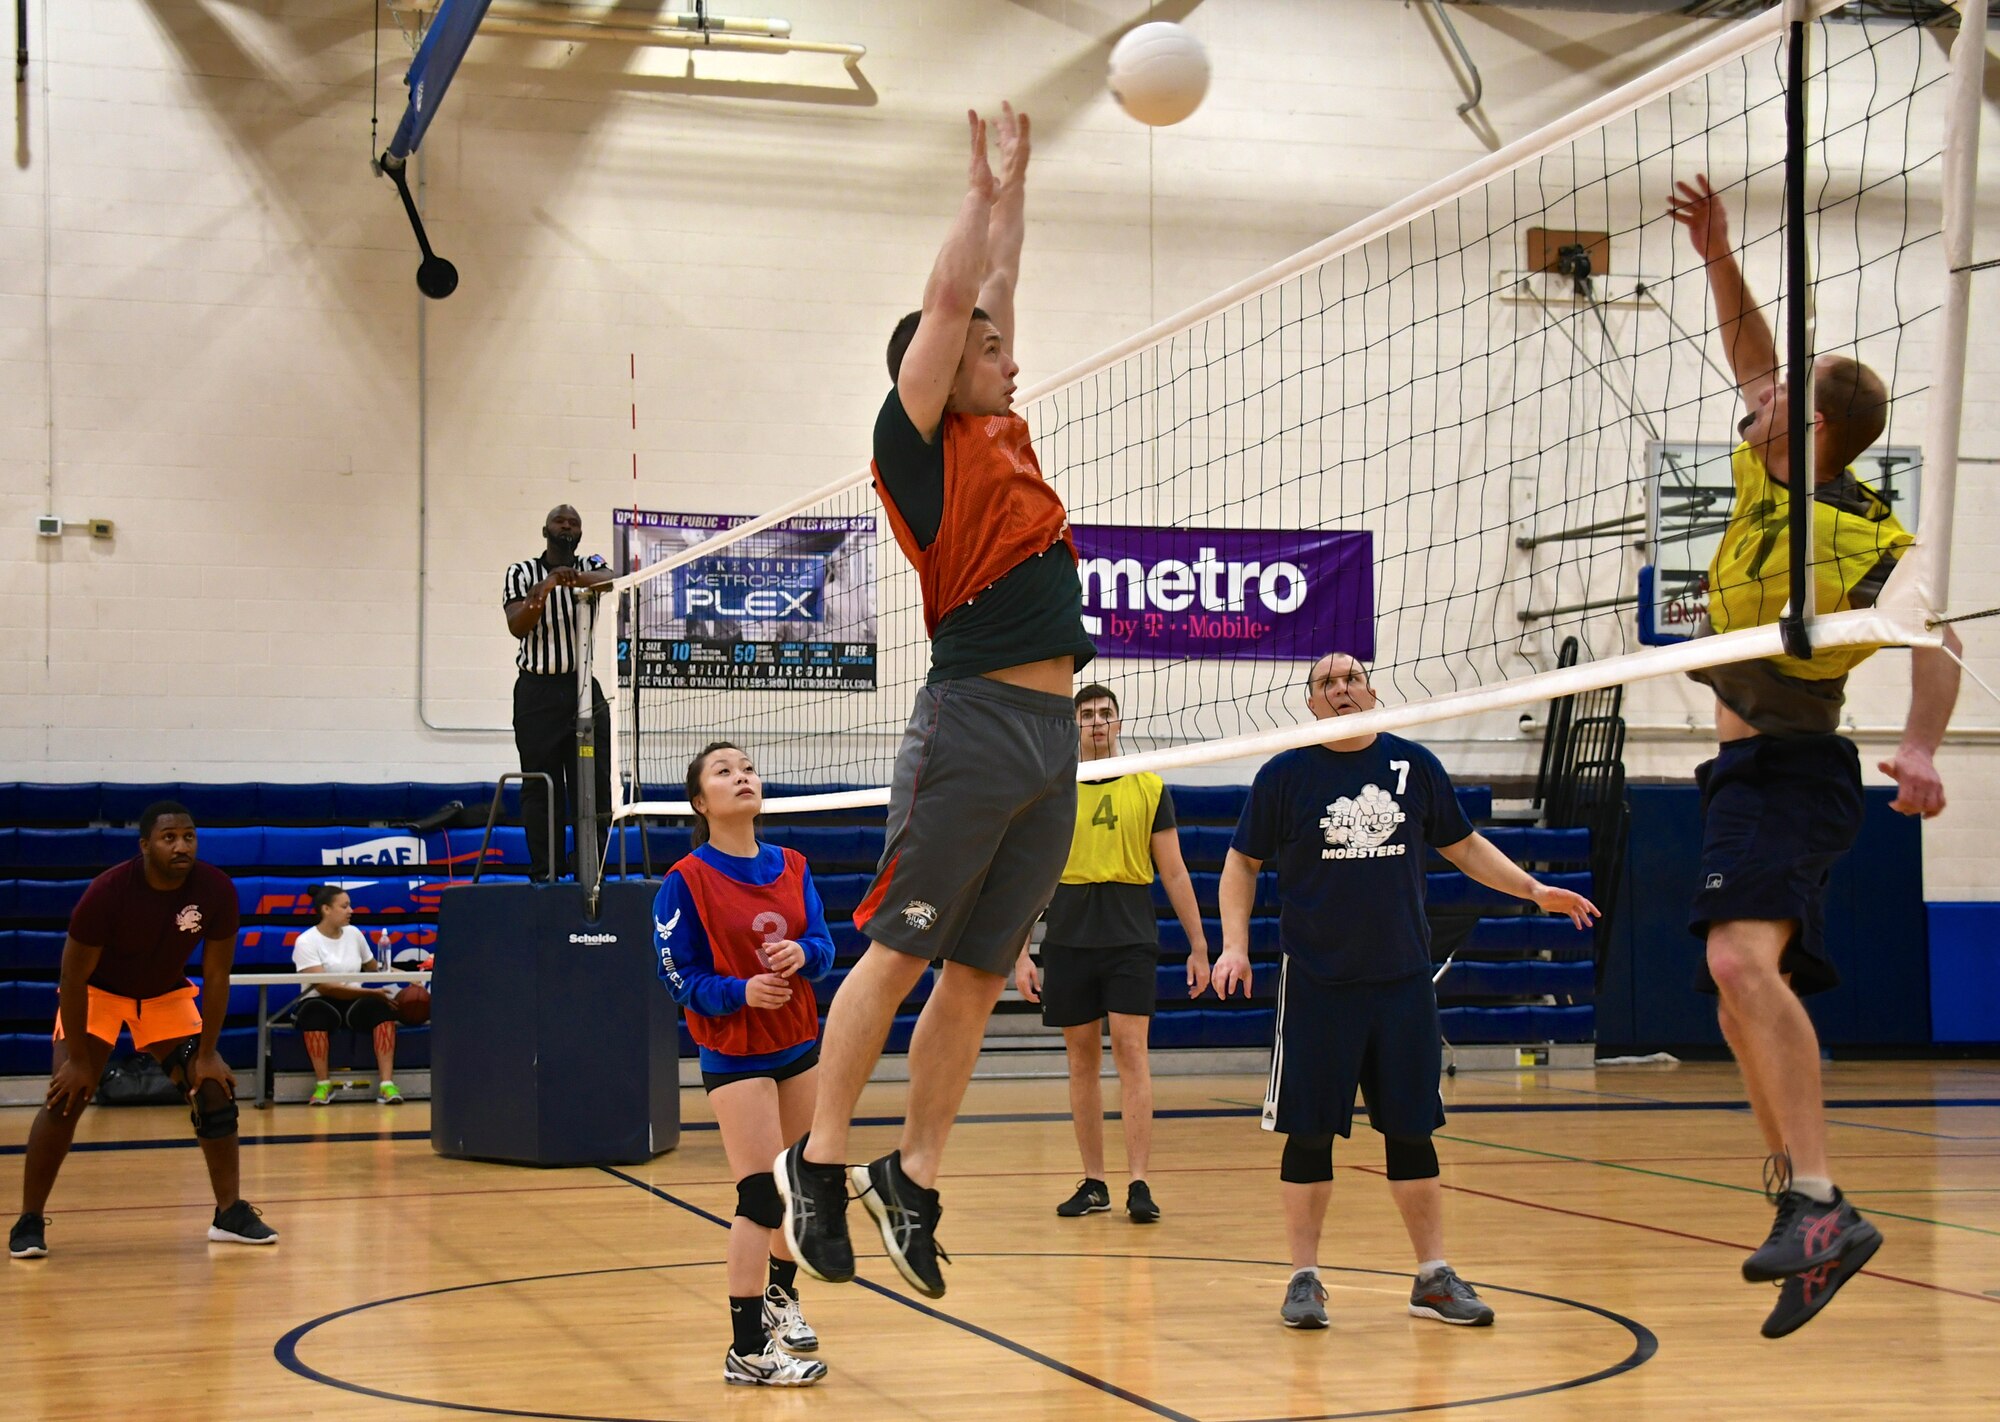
[0, 0, 2000, 898]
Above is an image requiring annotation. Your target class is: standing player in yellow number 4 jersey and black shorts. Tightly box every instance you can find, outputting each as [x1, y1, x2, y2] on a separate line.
[1014, 684, 1208, 1224]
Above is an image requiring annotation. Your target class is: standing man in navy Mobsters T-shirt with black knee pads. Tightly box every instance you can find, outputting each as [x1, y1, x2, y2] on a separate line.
[1214, 652, 1598, 1328]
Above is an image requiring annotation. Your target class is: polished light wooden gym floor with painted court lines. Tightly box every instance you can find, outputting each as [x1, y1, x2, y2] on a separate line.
[0, 1062, 2000, 1422]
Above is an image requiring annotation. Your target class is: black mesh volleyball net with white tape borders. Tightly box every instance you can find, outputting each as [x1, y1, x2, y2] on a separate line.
[614, 0, 1984, 816]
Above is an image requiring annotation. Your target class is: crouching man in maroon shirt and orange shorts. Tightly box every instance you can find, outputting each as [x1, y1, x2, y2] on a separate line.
[8, 800, 278, 1260]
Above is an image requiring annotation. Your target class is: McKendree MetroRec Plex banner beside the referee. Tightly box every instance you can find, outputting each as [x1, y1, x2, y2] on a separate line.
[612, 508, 876, 692]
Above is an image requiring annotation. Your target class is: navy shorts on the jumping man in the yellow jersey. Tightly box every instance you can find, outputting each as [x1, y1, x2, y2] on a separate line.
[1688, 736, 1862, 996]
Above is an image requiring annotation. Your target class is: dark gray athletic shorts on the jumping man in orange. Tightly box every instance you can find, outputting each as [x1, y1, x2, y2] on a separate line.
[854, 676, 1076, 976]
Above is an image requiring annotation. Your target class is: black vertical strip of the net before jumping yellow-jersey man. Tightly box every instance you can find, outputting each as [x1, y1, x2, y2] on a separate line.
[1778, 0, 1818, 660]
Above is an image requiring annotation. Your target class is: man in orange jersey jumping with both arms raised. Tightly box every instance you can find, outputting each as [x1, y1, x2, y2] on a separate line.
[774, 104, 1094, 1298]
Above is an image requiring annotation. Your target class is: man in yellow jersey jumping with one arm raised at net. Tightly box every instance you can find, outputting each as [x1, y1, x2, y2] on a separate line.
[1672, 174, 1958, 1338]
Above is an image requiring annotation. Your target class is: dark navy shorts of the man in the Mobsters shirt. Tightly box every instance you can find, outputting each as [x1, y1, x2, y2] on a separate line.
[1264, 958, 1444, 1138]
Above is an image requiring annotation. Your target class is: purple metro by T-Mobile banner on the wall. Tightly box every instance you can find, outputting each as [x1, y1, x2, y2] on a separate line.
[1070, 524, 1374, 662]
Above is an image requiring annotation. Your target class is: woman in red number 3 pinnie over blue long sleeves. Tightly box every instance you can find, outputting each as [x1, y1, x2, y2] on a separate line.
[652, 740, 834, 1388]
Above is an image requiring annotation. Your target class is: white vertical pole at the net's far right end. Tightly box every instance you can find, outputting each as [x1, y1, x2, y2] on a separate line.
[1882, 0, 1986, 620]
